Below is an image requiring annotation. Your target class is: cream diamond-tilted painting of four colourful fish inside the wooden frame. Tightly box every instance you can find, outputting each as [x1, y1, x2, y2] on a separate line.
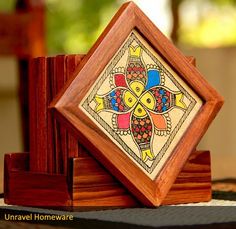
[79, 31, 202, 179]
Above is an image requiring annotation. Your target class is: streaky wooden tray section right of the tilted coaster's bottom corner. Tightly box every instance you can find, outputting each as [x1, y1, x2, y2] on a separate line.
[162, 151, 212, 205]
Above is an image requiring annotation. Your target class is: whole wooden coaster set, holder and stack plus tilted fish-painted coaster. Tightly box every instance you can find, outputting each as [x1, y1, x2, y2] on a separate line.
[4, 2, 223, 209]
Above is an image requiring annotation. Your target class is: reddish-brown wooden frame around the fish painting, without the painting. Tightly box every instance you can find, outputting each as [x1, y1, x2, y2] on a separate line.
[51, 2, 223, 206]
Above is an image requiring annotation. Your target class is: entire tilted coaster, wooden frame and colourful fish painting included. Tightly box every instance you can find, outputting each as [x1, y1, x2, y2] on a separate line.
[51, 2, 223, 206]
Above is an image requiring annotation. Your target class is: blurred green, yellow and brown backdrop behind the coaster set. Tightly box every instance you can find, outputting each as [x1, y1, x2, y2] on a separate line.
[0, 0, 236, 192]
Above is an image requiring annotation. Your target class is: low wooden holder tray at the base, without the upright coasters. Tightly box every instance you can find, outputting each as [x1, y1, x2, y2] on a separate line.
[4, 150, 211, 210]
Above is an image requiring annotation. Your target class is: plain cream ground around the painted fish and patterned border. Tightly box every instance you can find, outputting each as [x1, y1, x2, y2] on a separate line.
[79, 30, 202, 180]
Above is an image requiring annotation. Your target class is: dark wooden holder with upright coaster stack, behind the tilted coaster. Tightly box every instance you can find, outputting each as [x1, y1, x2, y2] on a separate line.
[4, 55, 211, 209]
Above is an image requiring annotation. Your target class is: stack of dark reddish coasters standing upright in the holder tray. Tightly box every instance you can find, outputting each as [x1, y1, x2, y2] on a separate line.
[29, 55, 83, 174]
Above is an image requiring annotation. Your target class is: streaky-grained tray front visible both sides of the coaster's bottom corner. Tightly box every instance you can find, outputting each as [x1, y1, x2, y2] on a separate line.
[72, 151, 211, 207]
